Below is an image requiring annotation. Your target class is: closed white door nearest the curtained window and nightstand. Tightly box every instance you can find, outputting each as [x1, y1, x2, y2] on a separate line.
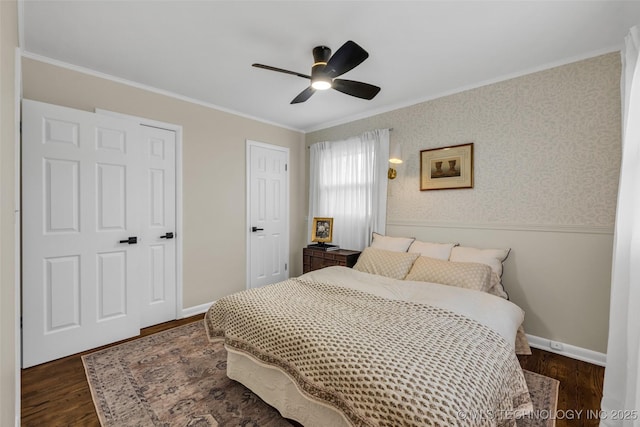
[247, 141, 289, 288]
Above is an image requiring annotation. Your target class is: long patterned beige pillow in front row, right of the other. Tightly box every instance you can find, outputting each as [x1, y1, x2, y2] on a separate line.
[405, 257, 493, 292]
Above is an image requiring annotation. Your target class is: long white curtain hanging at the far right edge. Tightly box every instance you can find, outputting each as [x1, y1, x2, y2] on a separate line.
[600, 26, 640, 426]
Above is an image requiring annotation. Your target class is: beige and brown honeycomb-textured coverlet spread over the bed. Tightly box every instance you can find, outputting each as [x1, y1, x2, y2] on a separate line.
[205, 278, 531, 426]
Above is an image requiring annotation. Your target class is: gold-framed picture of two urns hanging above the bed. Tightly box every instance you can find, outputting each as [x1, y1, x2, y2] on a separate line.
[420, 142, 473, 191]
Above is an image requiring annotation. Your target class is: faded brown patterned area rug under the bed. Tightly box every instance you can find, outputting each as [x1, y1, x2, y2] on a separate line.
[82, 321, 559, 427]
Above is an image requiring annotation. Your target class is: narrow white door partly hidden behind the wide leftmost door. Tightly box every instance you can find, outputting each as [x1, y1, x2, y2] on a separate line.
[140, 126, 177, 328]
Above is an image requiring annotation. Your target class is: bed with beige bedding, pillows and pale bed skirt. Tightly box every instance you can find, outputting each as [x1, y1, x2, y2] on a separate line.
[205, 241, 532, 427]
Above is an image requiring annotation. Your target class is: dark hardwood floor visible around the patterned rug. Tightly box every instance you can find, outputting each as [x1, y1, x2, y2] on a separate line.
[21, 315, 604, 427]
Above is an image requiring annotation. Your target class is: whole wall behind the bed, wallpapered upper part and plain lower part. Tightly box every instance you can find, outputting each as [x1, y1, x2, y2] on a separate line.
[306, 53, 621, 352]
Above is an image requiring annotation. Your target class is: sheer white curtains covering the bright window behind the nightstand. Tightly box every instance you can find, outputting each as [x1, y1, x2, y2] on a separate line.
[309, 129, 389, 250]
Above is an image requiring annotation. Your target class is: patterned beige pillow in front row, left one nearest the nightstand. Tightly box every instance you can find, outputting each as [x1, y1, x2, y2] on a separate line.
[353, 247, 419, 280]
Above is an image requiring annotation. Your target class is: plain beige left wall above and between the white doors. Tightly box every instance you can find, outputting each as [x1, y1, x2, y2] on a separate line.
[23, 58, 306, 308]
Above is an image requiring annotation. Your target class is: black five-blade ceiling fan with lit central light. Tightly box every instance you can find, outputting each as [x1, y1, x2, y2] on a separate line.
[252, 40, 380, 104]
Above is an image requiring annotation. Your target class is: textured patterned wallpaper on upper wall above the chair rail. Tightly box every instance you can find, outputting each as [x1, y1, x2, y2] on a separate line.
[306, 52, 621, 231]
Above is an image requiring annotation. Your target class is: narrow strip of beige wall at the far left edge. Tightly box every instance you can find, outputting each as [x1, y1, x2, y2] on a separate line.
[0, 0, 19, 426]
